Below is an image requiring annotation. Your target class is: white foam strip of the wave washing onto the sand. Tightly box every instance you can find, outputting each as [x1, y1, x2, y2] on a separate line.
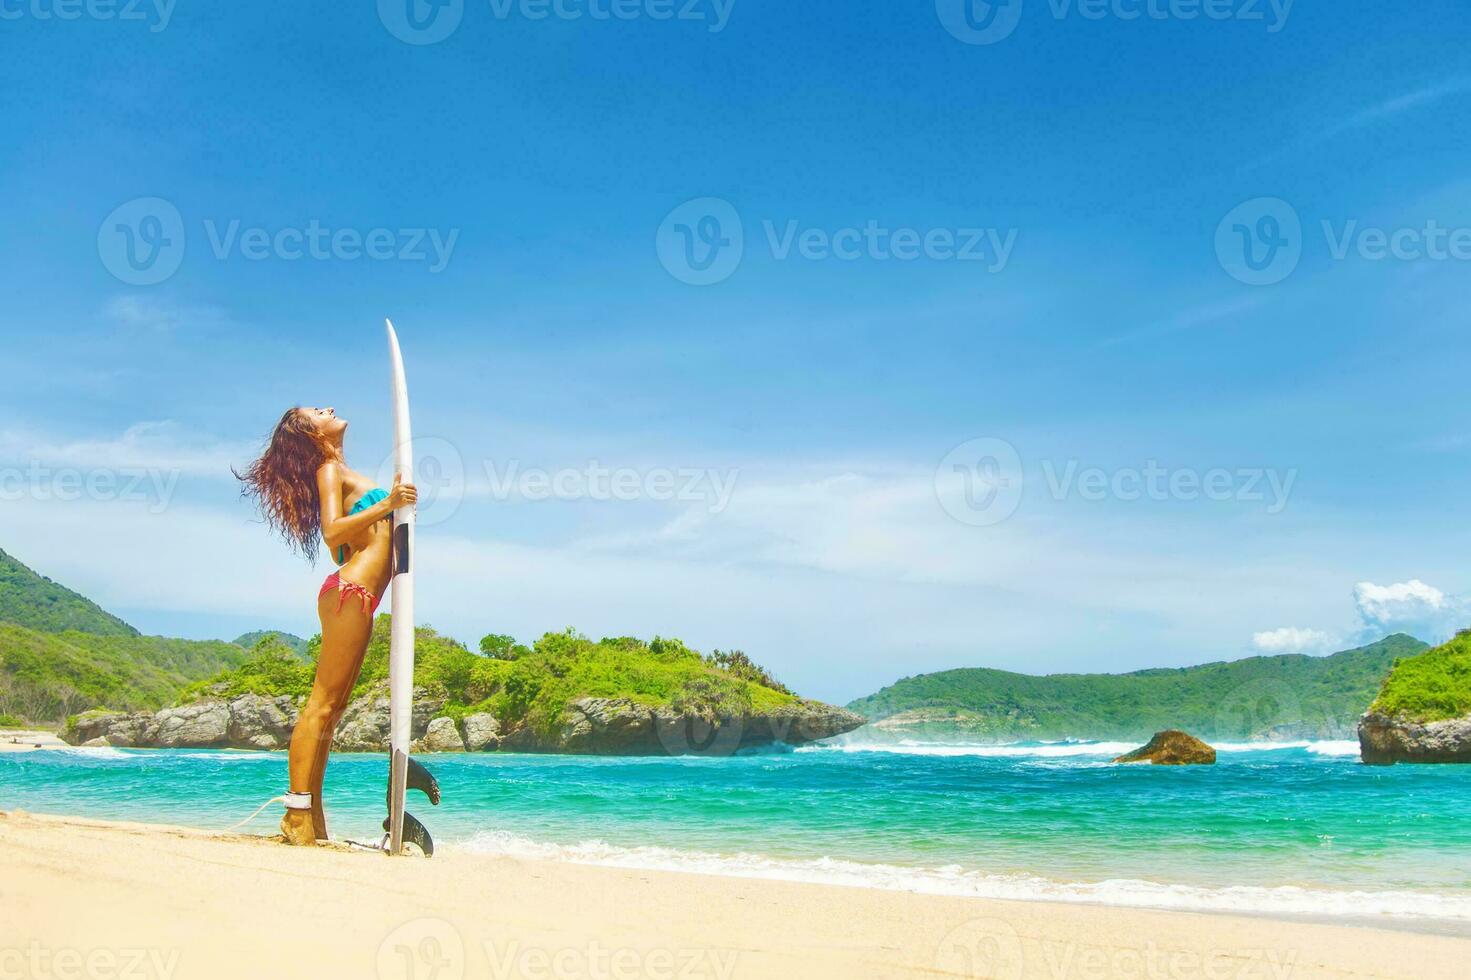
[446, 831, 1471, 921]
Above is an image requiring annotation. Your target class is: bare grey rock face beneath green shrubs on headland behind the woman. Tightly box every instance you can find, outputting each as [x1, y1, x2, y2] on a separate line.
[63, 689, 863, 755]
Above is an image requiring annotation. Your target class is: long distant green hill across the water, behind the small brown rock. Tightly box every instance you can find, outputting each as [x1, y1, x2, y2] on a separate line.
[847, 634, 1425, 742]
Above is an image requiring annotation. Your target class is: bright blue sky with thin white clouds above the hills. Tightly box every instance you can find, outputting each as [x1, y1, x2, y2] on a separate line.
[0, 0, 1471, 700]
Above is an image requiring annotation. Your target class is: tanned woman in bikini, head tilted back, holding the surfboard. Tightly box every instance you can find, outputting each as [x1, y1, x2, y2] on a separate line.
[235, 408, 419, 845]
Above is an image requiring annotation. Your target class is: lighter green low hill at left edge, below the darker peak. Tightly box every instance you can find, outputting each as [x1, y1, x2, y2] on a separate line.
[0, 622, 249, 722]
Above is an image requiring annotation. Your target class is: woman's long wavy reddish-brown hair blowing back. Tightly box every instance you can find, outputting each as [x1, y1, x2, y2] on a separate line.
[231, 406, 340, 562]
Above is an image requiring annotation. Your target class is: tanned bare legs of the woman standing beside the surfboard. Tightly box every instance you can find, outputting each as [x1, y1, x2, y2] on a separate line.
[281, 590, 372, 843]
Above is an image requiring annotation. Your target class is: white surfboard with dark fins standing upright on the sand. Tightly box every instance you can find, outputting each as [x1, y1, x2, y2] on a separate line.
[384, 319, 440, 855]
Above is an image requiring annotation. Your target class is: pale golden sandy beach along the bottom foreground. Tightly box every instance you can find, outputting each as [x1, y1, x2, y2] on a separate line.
[0, 811, 1471, 980]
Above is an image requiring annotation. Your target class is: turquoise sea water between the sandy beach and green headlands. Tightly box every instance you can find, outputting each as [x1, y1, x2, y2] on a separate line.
[0, 742, 1471, 931]
